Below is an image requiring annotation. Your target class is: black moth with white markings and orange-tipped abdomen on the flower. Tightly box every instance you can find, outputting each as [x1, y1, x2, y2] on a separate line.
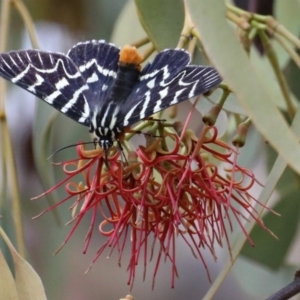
[0, 40, 222, 151]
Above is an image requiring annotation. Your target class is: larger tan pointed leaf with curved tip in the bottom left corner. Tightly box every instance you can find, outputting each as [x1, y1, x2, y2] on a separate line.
[0, 228, 47, 300]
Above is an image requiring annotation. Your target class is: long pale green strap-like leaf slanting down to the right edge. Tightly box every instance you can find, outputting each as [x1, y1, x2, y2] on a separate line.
[187, 0, 300, 174]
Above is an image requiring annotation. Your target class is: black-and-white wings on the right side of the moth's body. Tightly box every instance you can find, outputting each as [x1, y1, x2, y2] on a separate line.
[122, 49, 222, 126]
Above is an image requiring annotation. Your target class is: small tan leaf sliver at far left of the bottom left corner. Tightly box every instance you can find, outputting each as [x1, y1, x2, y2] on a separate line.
[0, 251, 18, 300]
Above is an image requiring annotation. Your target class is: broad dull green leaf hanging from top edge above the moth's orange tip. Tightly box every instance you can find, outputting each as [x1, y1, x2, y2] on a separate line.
[134, 0, 184, 50]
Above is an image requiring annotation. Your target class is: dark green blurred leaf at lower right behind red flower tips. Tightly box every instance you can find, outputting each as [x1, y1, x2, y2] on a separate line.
[242, 147, 300, 270]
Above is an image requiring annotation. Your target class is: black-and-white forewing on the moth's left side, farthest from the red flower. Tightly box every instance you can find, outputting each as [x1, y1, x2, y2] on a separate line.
[0, 50, 90, 126]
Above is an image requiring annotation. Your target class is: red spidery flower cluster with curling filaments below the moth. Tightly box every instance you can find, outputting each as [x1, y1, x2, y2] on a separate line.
[33, 120, 265, 286]
